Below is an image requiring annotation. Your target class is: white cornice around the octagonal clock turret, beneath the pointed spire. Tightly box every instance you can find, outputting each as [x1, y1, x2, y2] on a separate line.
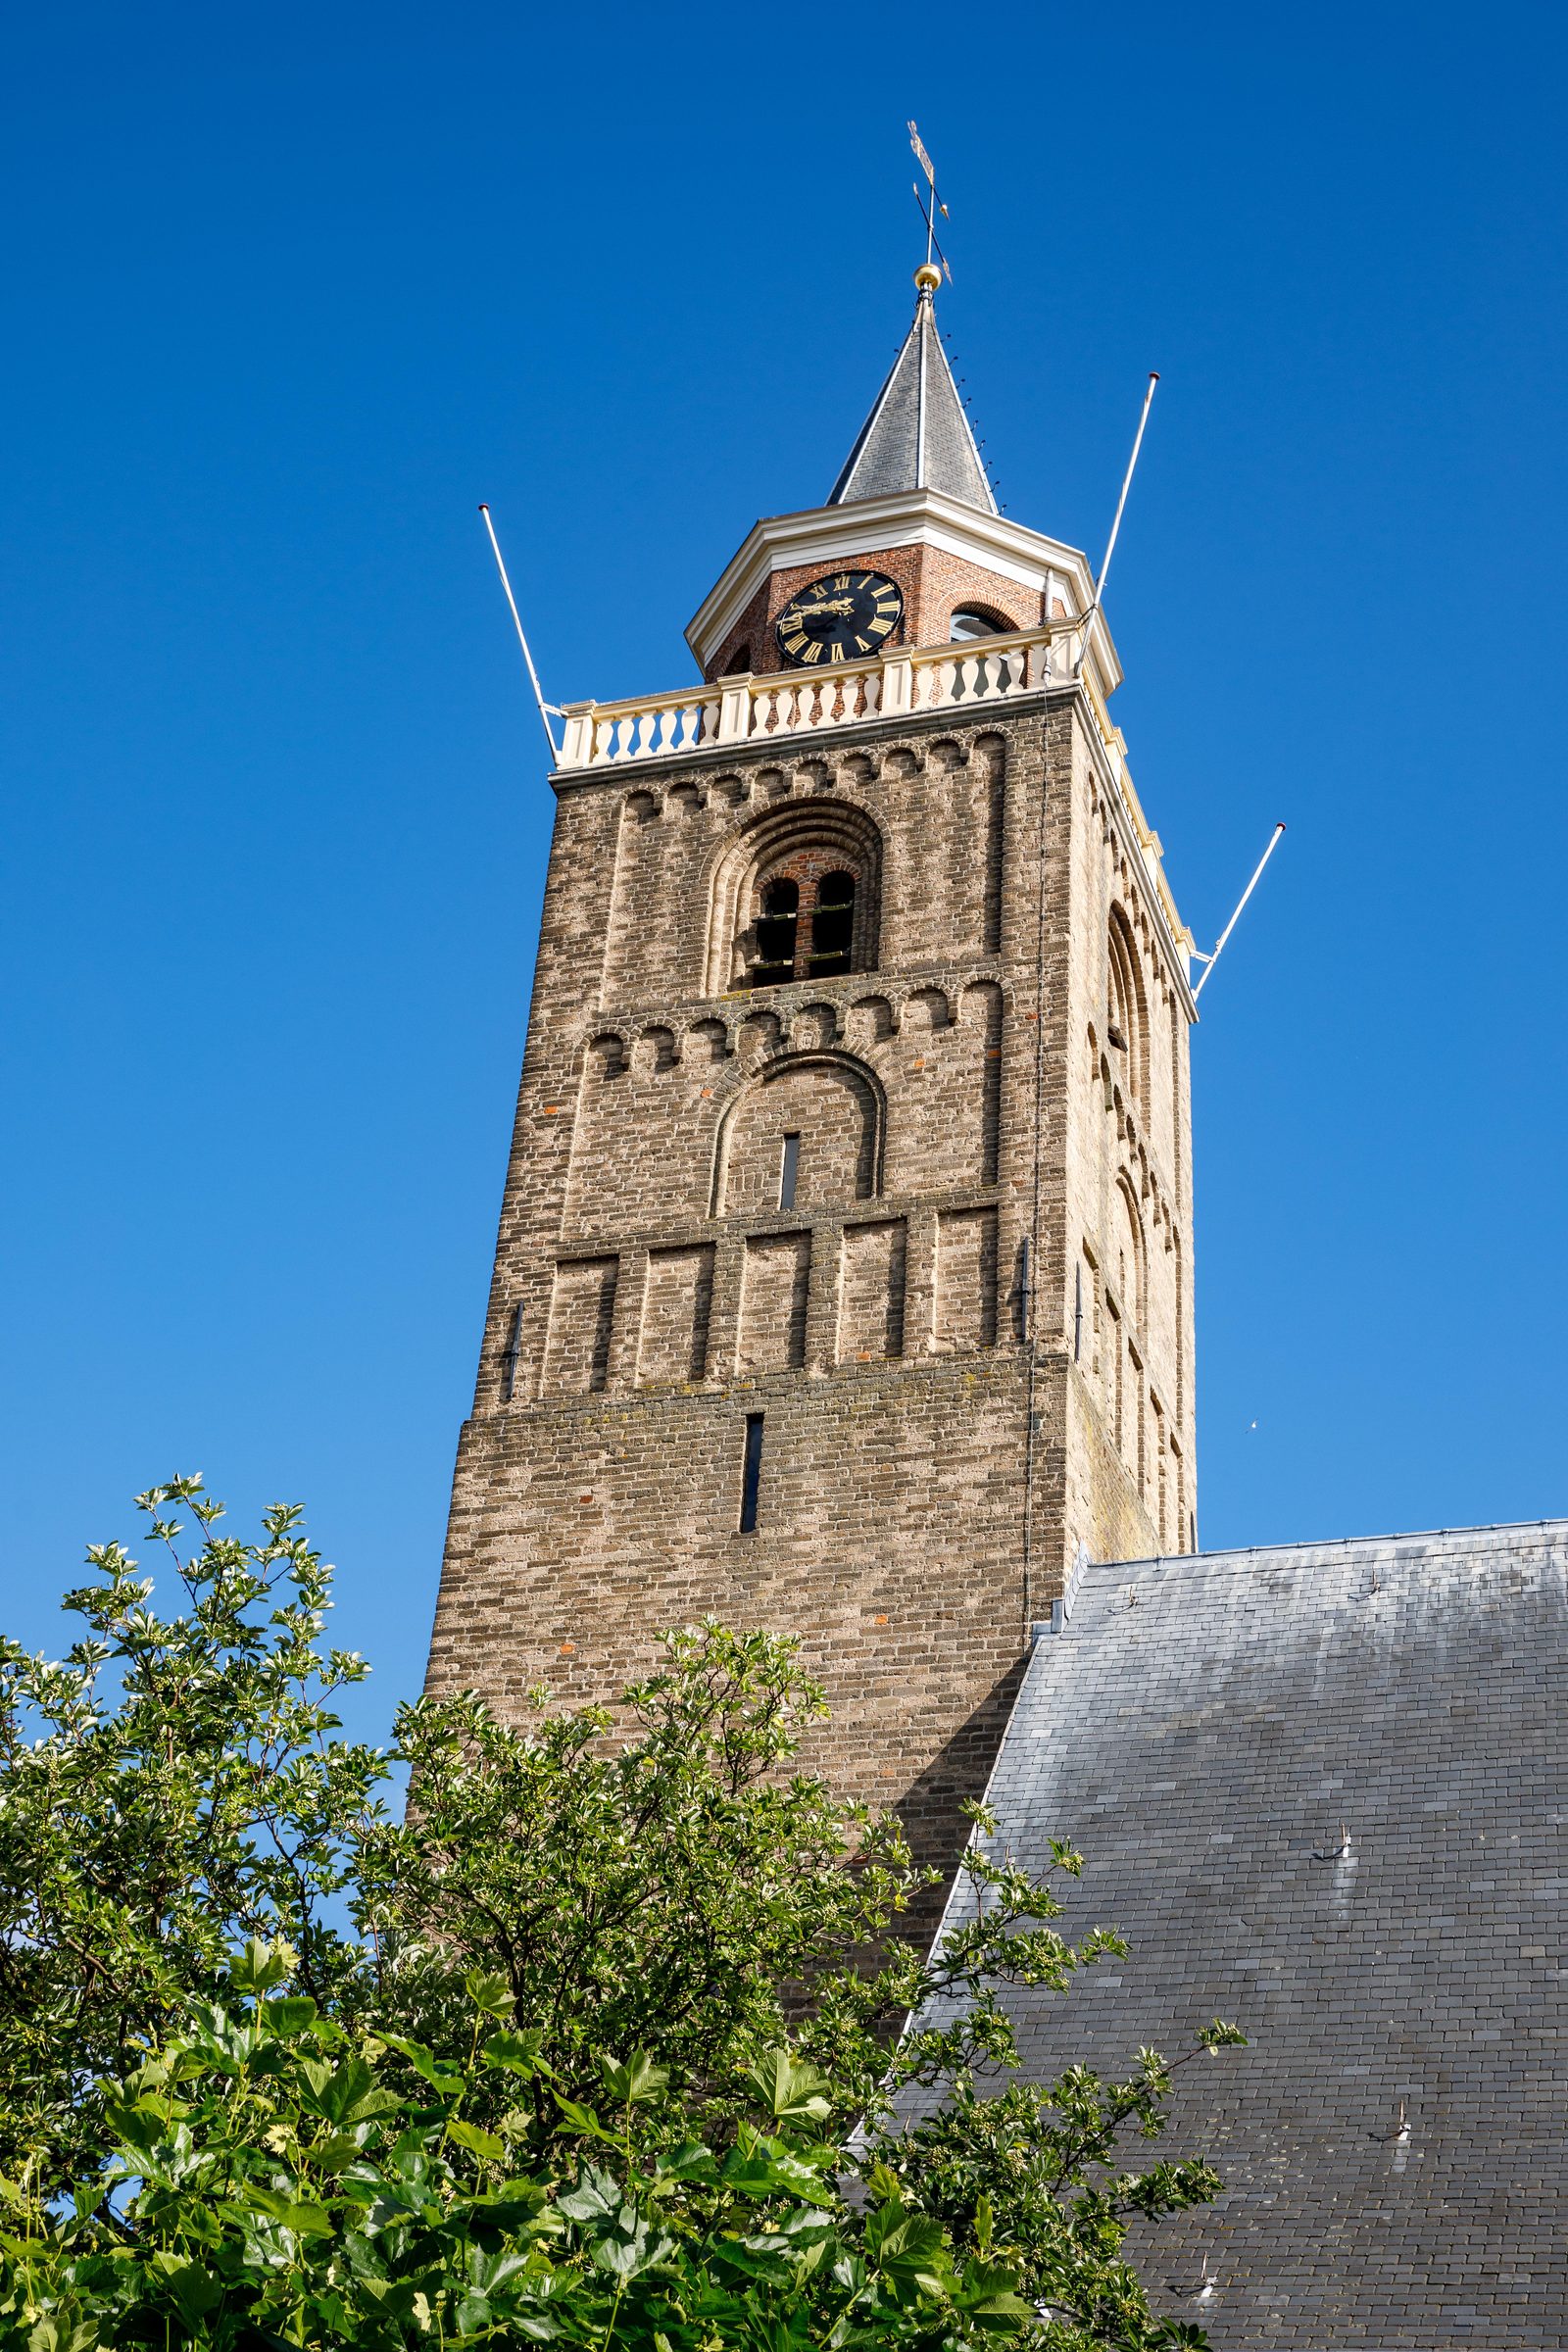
[686, 489, 1121, 694]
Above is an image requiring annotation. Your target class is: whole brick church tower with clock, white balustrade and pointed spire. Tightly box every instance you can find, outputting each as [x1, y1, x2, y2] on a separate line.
[430, 269, 1195, 1860]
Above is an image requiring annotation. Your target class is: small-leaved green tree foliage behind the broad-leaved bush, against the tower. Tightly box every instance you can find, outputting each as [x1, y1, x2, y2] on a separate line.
[0, 1480, 1239, 2347]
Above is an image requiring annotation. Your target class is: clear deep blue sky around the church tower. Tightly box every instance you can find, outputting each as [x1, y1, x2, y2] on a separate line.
[0, 0, 1568, 1724]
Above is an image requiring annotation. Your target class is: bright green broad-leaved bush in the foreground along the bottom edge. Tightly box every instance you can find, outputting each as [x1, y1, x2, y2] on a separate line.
[0, 1942, 1048, 2352]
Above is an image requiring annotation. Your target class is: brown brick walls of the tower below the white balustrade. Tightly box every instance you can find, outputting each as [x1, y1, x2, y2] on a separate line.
[430, 692, 1192, 1890]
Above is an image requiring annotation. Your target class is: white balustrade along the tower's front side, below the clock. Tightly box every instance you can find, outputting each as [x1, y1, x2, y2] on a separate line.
[562, 623, 1079, 769]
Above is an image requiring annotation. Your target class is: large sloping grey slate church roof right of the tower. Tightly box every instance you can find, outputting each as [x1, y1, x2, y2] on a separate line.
[921, 1519, 1568, 2352]
